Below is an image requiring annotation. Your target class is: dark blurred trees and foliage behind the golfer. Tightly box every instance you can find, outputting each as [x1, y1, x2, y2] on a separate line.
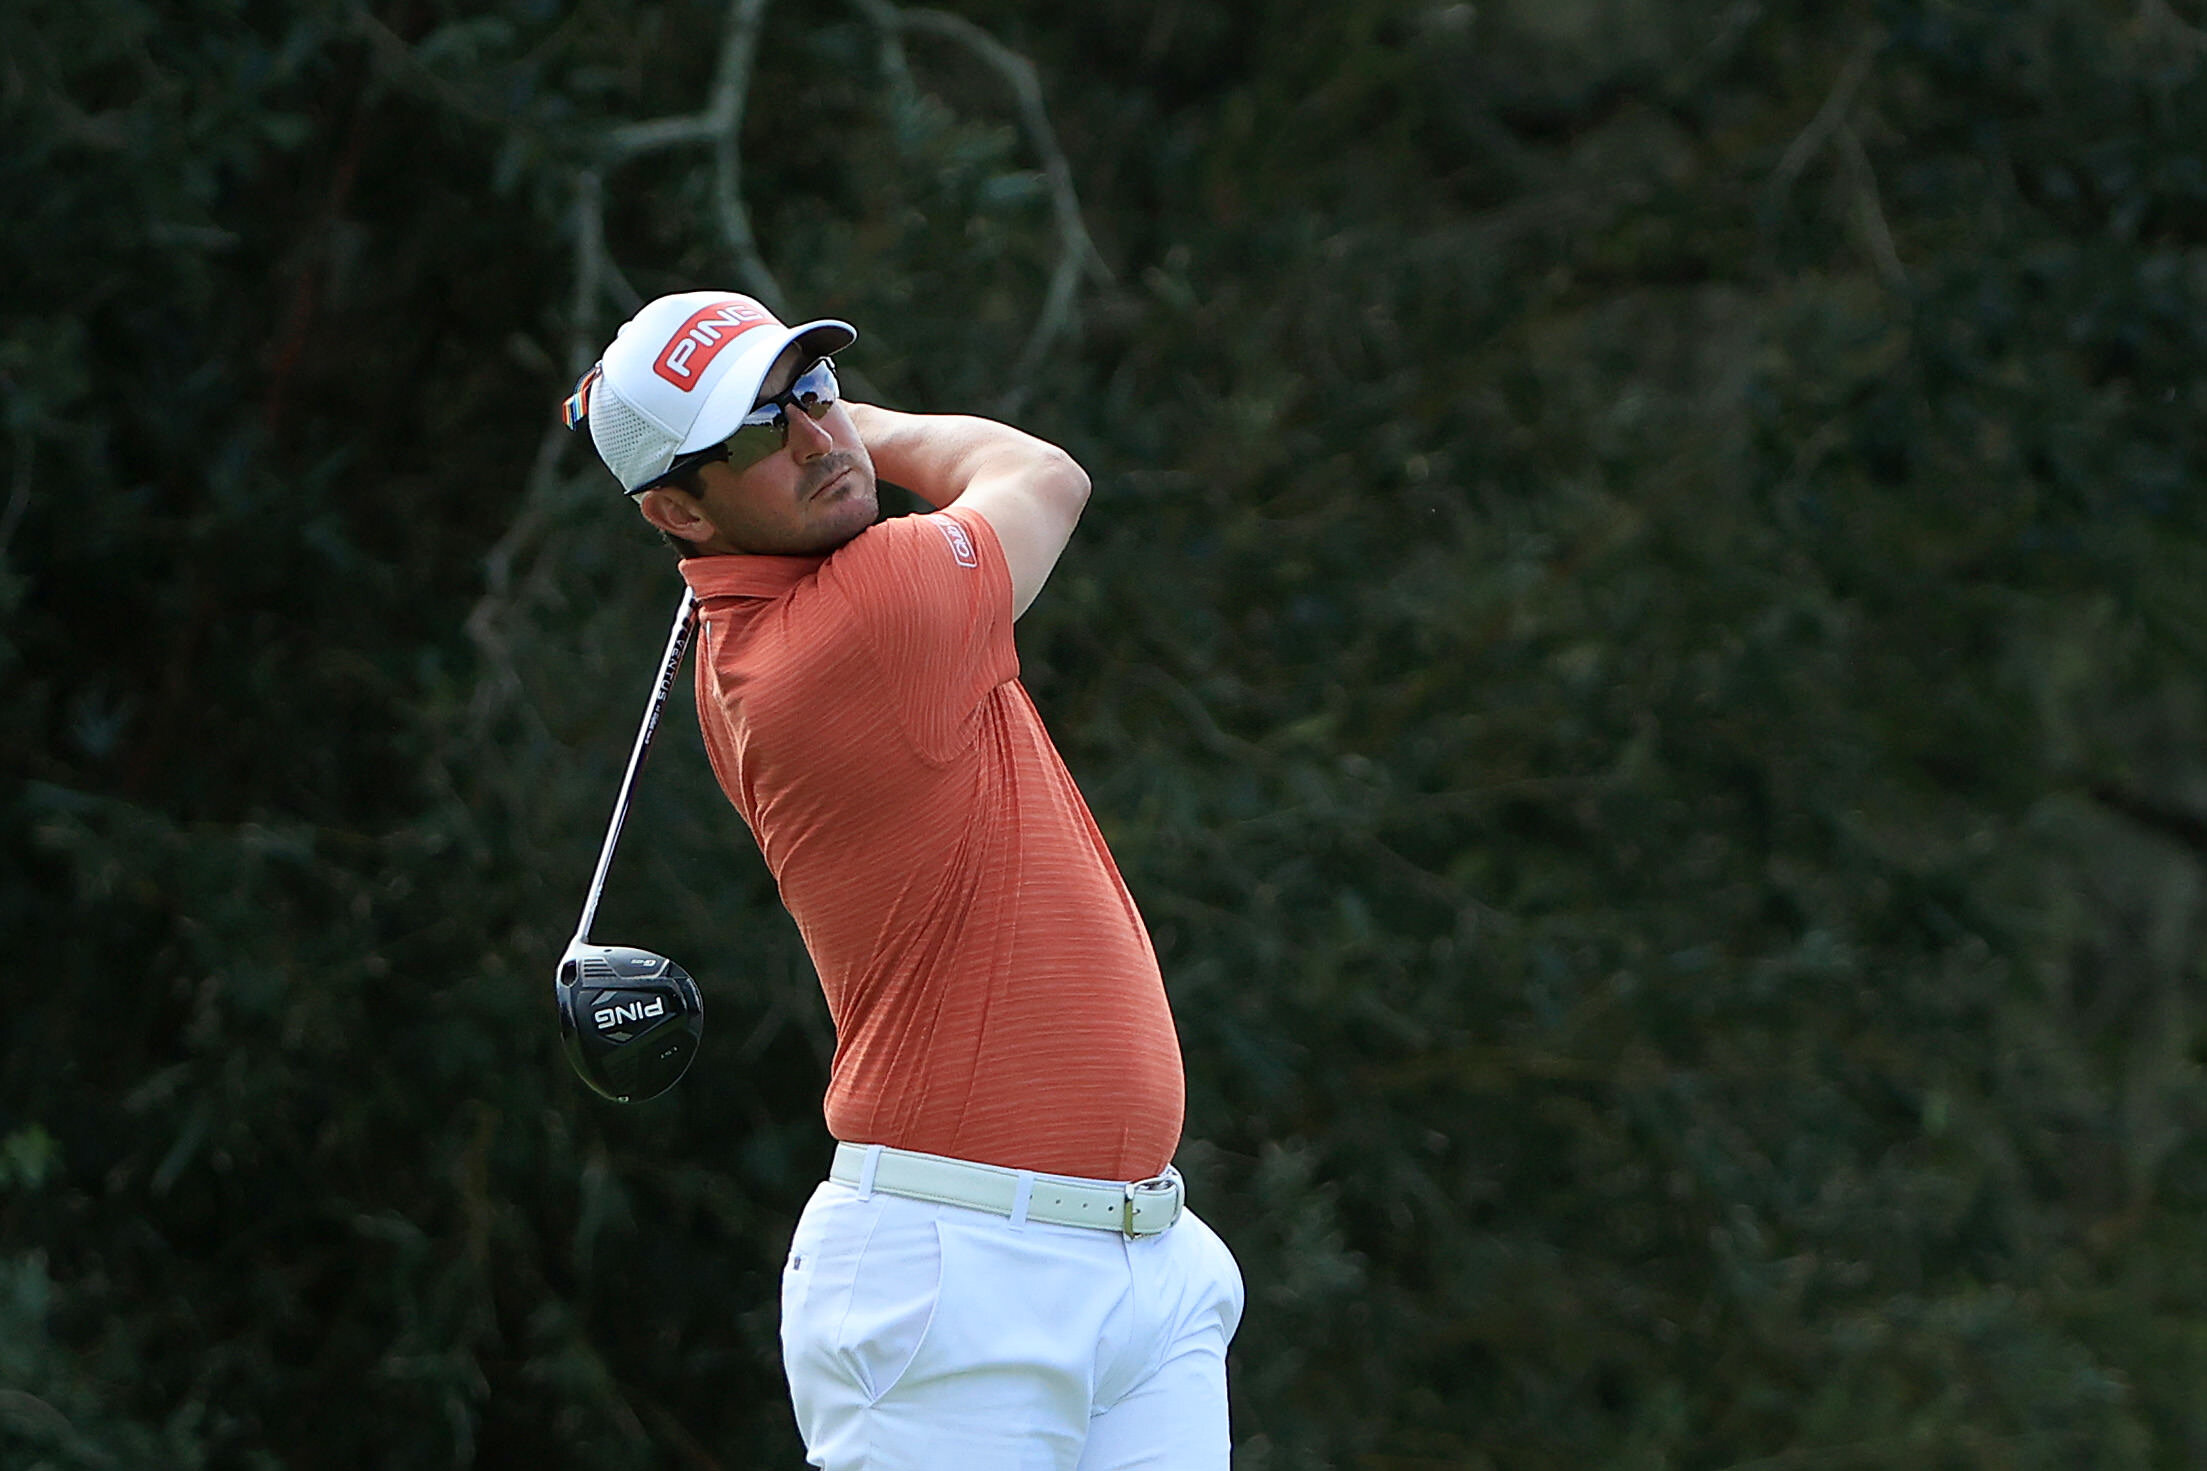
[0, 0, 2207, 1471]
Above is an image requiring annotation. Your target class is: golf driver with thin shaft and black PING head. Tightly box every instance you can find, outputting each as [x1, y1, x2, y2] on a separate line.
[552, 589, 704, 1103]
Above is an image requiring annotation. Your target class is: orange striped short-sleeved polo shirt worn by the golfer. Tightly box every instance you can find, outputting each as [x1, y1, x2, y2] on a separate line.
[682, 505, 1183, 1180]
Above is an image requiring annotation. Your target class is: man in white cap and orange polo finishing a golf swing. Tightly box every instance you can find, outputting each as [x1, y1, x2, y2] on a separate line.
[567, 291, 1243, 1471]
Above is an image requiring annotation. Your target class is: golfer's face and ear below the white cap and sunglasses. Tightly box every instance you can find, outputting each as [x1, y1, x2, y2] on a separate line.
[640, 352, 878, 556]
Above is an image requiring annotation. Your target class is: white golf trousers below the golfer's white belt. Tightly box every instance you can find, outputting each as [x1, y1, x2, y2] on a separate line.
[781, 1182, 1243, 1471]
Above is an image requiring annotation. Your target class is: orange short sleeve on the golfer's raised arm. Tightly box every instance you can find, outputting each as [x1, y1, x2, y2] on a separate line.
[821, 507, 1020, 761]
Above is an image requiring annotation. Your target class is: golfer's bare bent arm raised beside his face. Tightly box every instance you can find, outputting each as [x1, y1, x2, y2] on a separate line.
[850, 404, 1088, 618]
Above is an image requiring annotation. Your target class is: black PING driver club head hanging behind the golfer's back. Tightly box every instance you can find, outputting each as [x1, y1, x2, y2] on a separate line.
[554, 939, 704, 1103]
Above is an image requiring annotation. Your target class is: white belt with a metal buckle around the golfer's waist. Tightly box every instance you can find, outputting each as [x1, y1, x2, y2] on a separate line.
[828, 1145, 1185, 1235]
